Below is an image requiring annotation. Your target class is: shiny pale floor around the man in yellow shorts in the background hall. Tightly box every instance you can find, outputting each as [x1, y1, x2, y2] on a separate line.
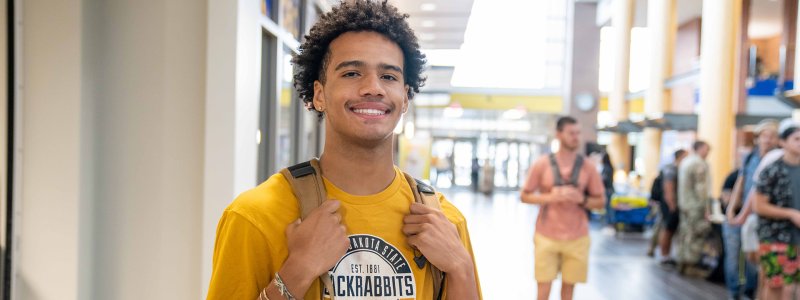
[443, 190, 726, 300]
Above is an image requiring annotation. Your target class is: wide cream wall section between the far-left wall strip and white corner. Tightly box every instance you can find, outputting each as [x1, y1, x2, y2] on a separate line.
[84, 0, 206, 299]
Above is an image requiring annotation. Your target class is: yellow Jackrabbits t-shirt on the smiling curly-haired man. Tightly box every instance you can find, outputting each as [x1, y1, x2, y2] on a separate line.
[208, 168, 480, 300]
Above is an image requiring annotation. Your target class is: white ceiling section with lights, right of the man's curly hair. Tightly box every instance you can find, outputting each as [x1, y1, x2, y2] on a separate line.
[389, 0, 473, 49]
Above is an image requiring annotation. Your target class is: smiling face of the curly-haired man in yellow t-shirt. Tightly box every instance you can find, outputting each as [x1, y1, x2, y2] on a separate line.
[314, 31, 408, 145]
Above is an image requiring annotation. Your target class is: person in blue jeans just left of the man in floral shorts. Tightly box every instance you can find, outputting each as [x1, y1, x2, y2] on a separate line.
[722, 119, 778, 299]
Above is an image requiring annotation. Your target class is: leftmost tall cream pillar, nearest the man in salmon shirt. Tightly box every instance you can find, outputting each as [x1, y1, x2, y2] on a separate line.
[608, 0, 635, 170]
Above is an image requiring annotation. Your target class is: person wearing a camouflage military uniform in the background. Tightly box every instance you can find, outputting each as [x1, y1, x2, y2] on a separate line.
[678, 141, 711, 275]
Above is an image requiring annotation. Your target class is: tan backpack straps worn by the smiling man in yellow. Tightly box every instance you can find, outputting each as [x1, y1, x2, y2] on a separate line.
[280, 158, 445, 299]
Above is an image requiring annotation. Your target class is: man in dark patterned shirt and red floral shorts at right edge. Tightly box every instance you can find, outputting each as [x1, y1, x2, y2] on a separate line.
[753, 121, 800, 300]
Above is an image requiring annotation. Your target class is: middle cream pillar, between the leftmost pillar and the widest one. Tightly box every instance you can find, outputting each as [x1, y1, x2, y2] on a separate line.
[642, 0, 678, 188]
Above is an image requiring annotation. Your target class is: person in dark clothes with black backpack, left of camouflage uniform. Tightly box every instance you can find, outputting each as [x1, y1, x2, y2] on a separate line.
[658, 149, 688, 267]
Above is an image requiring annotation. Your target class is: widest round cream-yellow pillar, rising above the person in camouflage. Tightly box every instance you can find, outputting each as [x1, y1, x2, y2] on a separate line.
[697, 0, 742, 197]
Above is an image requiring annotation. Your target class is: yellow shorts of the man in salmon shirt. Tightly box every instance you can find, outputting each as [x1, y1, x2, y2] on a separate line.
[533, 233, 590, 283]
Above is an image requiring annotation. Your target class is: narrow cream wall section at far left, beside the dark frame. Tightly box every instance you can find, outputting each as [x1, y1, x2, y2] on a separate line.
[14, 0, 88, 299]
